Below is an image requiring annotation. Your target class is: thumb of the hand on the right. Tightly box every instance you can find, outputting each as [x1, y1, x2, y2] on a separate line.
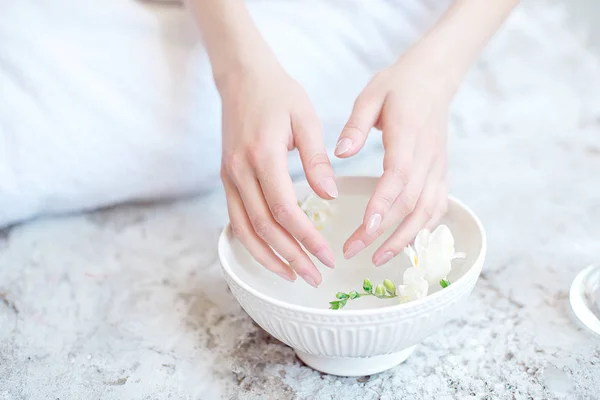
[334, 88, 385, 158]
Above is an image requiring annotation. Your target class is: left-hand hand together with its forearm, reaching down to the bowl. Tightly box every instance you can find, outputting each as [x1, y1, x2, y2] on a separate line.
[189, 0, 337, 287]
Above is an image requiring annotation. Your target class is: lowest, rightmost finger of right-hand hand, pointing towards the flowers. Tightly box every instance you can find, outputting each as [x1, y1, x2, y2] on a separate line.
[373, 156, 442, 267]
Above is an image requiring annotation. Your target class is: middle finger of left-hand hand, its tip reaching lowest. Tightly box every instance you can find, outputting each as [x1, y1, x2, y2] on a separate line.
[235, 172, 322, 287]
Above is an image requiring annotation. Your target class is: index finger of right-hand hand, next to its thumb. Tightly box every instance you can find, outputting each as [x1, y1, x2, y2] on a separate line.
[363, 101, 416, 235]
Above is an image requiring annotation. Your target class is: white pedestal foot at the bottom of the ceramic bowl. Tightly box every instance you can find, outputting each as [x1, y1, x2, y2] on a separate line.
[296, 345, 416, 376]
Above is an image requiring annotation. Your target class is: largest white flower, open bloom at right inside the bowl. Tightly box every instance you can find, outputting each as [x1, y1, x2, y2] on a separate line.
[404, 225, 465, 285]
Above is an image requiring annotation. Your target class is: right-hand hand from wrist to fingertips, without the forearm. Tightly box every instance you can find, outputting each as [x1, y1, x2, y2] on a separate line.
[335, 46, 456, 266]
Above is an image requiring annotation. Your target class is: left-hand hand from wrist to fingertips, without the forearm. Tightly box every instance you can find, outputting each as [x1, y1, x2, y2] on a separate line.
[219, 61, 338, 287]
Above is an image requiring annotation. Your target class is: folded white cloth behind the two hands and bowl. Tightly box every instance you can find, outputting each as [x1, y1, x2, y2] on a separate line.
[0, 0, 447, 226]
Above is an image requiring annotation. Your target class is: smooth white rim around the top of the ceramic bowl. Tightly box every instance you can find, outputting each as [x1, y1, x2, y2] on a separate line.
[218, 175, 487, 317]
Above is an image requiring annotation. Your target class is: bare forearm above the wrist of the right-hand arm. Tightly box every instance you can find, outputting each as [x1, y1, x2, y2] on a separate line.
[415, 0, 519, 89]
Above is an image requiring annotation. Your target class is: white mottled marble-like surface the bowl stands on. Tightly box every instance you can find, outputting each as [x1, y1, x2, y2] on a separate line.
[0, 3, 600, 400]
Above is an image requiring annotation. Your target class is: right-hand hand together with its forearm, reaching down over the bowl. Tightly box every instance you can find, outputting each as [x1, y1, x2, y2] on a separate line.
[335, 0, 519, 265]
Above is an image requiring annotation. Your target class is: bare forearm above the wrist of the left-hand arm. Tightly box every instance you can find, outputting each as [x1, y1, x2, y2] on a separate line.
[187, 0, 275, 90]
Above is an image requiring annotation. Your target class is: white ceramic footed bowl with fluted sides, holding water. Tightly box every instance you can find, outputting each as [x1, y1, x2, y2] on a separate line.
[219, 177, 486, 376]
